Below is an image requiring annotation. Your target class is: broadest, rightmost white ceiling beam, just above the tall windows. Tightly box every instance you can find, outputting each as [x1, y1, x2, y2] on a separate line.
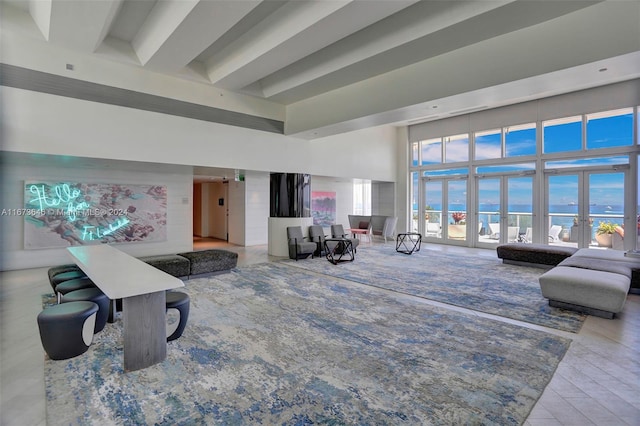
[285, 2, 640, 137]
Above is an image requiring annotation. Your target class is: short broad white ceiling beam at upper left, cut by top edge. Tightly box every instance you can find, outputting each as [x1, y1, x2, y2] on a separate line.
[47, 0, 122, 53]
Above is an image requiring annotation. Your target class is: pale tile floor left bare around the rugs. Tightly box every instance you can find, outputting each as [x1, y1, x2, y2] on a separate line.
[0, 240, 640, 426]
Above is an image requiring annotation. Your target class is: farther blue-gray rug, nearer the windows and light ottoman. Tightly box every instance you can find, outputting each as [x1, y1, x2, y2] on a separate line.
[284, 243, 586, 333]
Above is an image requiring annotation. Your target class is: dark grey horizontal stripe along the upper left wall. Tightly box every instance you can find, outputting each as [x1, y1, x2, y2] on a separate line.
[0, 64, 284, 134]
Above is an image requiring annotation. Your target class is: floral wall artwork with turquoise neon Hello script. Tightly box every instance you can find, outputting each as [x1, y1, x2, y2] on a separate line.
[22, 182, 167, 249]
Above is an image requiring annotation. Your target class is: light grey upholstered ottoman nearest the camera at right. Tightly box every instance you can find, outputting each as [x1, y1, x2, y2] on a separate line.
[539, 266, 630, 318]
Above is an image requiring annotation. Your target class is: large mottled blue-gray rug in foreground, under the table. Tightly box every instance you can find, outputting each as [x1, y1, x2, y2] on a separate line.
[45, 261, 570, 425]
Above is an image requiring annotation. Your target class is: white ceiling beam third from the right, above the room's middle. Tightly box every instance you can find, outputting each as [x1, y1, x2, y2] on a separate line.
[208, 0, 417, 90]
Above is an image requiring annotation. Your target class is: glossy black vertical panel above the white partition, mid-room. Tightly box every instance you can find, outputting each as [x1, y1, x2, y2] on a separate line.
[270, 173, 311, 217]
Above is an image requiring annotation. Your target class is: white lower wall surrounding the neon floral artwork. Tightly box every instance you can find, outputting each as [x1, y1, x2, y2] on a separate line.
[0, 160, 193, 270]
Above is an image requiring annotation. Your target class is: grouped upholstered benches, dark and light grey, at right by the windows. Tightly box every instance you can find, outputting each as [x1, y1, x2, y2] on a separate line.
[497, 243, 640, 318]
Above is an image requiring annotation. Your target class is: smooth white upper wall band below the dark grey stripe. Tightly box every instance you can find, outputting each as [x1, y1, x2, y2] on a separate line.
[0, 86, 396, 182]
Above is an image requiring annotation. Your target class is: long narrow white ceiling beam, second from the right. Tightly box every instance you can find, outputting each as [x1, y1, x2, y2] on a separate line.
[260, 0, 514, 98]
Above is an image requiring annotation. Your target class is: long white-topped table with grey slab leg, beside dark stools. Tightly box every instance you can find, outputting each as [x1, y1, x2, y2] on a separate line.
[67, 244, 184, 371]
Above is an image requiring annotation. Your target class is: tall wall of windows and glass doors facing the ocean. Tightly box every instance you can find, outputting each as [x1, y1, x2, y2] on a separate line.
[409, 85, 640, 249]
